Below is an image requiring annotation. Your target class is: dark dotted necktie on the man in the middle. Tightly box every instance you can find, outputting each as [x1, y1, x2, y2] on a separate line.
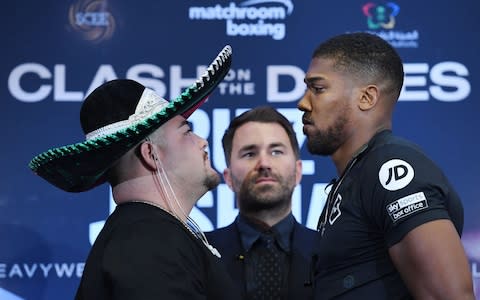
[253, 235, 282, 300]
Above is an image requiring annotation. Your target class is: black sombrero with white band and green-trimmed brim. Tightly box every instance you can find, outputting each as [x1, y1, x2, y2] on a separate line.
[29, 45, 232, 192]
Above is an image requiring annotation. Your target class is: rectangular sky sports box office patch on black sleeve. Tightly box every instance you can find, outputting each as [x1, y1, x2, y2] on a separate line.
[386, 192, 428, 223]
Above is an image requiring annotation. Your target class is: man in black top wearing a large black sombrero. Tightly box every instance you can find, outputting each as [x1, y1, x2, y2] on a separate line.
[29, 46, 237, 300]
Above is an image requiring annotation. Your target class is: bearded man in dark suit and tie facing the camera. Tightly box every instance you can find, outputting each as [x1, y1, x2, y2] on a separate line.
[207, 106, 316, 300]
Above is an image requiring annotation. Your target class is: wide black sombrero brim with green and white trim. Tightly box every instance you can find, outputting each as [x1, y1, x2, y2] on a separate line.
[29, 46, 232, 192]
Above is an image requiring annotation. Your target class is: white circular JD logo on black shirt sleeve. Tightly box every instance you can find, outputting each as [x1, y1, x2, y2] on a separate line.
[378, 159, 415, 191]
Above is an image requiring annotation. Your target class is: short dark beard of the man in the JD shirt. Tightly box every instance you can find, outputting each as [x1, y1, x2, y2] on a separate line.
[307, 114, 348, 156]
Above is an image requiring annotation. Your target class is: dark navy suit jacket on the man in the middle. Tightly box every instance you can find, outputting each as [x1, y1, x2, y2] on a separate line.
[205, 221, 317, 300]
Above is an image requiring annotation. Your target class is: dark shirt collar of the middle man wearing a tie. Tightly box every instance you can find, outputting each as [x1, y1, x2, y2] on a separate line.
[235, 213, 295, 252]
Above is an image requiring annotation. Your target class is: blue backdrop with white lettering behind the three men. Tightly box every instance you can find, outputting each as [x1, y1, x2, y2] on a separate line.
[0, 0, 480, 300]
